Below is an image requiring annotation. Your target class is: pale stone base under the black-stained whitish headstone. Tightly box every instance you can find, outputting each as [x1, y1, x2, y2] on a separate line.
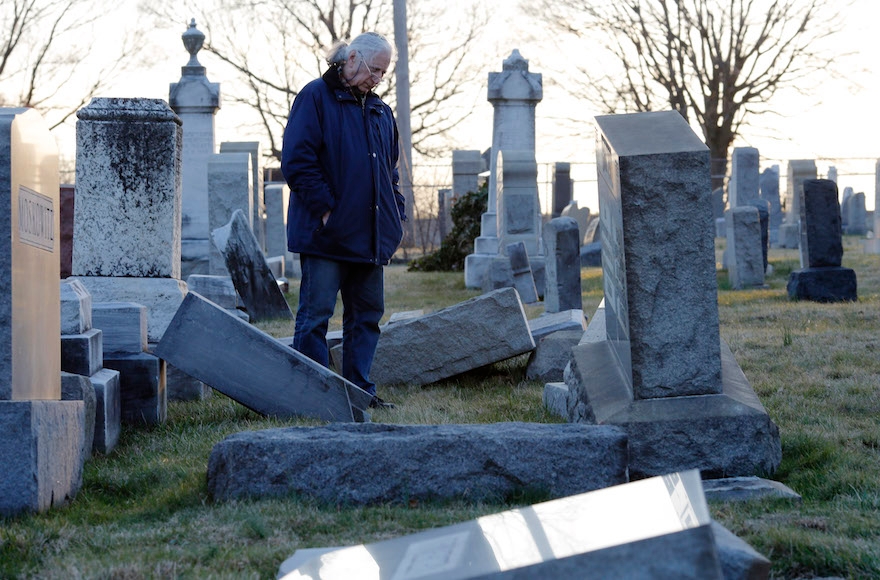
[76, 276, 187, 342]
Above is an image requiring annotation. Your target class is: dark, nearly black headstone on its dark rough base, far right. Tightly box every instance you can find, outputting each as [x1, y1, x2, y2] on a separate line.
[788, 179, 858, 302]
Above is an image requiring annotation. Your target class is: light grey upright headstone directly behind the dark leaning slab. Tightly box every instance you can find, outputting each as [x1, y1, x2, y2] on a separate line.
[208, 152, 254, 276]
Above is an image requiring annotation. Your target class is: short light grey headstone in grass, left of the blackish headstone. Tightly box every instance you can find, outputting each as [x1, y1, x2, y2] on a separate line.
[725, 205, 764, 290]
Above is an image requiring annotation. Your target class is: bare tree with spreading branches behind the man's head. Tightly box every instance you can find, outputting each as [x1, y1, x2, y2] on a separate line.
[141, 0, 486, 159]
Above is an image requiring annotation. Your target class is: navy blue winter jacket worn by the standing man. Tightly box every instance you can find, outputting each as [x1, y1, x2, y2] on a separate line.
[281, 67, 406, 264]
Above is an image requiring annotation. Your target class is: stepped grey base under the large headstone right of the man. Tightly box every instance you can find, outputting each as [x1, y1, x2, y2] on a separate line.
[565, 340, 782, 479]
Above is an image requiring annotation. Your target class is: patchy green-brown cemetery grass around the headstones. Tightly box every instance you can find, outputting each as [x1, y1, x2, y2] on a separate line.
[0, 236, 880, 579]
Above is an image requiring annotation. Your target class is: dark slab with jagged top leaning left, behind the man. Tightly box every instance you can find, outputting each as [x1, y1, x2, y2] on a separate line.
[211, 210, 293, 321]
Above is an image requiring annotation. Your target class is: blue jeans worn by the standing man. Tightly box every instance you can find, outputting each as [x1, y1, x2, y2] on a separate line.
[293, 254, 385, 395]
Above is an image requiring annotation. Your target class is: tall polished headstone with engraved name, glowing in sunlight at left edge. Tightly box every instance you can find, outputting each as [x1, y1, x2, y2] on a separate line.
[0, 108, 61, 401]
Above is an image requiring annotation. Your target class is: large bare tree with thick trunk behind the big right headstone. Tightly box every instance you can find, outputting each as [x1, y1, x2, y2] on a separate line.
[530, 0, 842, 186]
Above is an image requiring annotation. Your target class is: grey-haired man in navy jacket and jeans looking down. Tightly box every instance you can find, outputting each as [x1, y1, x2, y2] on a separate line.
[281, 32, 406, 408]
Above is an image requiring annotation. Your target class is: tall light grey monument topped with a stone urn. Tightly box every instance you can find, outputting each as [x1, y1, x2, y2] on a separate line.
[168, 19, 220, 278]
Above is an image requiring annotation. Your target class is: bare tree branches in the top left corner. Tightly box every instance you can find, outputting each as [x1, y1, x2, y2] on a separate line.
[0, 0, 141, 129]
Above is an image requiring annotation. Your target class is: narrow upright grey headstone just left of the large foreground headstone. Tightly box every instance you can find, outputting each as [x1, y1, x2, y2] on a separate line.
[543, 217, 584, 312]
